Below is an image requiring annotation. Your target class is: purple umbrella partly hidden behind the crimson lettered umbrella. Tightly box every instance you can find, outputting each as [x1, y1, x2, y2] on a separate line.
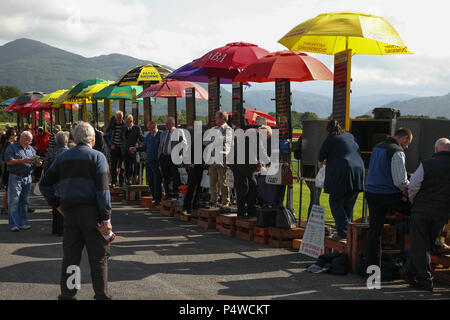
[165, 60, 248, 85]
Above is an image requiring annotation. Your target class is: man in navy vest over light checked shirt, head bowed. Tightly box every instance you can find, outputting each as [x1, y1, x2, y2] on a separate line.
[365, 128, 413, 270]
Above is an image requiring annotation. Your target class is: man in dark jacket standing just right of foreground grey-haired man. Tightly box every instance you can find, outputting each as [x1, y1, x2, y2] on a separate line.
[103, 110, 125, 187]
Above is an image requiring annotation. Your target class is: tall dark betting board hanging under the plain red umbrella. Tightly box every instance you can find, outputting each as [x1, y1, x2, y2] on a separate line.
[275, 79, 292, 139]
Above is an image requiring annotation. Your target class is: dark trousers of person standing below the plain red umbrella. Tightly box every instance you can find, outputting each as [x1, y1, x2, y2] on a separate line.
[231, 165, 258, 217]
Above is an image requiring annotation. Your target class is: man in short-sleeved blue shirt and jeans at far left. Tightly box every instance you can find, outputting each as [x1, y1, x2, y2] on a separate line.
[5, 131, 42, 232]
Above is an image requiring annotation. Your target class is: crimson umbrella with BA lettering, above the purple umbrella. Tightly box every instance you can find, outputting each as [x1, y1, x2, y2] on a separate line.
[192, 42, 269, 69]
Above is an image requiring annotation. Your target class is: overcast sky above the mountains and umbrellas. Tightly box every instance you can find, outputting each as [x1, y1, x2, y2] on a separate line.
[0, 0, 450, 96]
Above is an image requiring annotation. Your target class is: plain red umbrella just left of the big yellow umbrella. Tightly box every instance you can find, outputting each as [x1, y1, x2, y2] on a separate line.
[234, 51, 333, 82]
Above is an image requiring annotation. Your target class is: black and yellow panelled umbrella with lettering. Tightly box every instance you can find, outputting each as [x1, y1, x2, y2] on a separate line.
[114, 64, 173, 87]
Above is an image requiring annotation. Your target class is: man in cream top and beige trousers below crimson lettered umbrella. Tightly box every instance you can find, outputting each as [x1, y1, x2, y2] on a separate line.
[207, 111, 233, 208]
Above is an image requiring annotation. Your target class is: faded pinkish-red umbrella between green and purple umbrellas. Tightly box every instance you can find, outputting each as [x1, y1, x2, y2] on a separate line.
[137, 79, 208, 100]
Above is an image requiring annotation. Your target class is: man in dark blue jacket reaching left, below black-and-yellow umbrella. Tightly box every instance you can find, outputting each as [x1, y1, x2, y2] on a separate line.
[130, 121, 161, 206]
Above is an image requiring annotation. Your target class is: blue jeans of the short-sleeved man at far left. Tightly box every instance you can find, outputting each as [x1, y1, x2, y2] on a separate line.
[8, 174, 32, 228]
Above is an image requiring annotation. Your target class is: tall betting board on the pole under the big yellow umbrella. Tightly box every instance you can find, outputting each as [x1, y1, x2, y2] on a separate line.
[333, 50, 352, 130]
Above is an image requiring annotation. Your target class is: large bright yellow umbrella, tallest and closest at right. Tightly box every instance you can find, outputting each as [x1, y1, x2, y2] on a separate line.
[278, 12, 411, 55]
